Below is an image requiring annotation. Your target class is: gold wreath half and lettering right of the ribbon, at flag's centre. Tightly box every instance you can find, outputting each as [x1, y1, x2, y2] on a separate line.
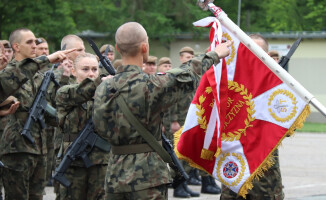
[222, 81, 256, 141]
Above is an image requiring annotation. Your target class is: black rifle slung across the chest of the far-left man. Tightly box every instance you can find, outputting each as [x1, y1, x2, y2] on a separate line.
[20, 63, 59, 145]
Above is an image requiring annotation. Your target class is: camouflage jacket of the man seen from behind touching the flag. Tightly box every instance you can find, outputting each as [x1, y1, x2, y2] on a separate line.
[93, 52, 219, 193]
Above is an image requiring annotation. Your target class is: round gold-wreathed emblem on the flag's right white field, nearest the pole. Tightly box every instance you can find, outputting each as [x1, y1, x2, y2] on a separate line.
[268, 89, 298, 123]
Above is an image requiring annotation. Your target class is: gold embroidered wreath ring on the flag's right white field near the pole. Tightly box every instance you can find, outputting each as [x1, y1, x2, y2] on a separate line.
[268, 89, 298, 123]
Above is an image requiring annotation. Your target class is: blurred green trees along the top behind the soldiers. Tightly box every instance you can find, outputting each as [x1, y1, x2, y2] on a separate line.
[0, 0, 326, 48]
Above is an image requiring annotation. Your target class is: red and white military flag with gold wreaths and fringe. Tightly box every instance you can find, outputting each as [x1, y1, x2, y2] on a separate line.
[175, 17, 310, 196]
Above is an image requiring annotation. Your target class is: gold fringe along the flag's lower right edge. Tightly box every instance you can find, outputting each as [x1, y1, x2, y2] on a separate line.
[238, 105, 310, 198]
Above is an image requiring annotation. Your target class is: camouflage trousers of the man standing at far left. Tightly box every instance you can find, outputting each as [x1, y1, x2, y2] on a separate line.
[1, 153, 46, 200]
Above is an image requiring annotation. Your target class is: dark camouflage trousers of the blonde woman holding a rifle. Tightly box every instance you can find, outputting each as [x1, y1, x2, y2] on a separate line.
[60, 165, 107, 200]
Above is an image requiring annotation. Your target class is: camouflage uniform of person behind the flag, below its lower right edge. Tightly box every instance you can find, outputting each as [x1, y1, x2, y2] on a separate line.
[220, 150, 284, 200]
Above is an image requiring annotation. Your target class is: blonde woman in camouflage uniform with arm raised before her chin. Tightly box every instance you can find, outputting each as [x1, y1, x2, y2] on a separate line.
[56, 53, 109, 200]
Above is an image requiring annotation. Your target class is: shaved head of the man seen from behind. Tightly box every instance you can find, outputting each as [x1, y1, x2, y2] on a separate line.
[115, 22, 148, 56]
